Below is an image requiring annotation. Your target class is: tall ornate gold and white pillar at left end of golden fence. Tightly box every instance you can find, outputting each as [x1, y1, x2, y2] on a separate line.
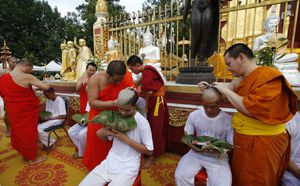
[93, 0, 108, 59]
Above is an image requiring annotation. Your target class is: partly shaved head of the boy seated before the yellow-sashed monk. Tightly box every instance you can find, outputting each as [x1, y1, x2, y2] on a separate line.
[202, 87, 221, 118]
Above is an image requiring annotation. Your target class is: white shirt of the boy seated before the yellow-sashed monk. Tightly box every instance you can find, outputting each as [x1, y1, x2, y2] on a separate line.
[184, 107, 233, 144]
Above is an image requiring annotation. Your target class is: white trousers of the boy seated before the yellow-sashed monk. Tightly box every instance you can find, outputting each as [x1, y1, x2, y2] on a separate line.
[175, 150, 232, 186]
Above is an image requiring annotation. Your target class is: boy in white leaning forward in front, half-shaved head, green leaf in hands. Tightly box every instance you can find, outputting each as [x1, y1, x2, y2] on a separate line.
[80, 88, 153, 186]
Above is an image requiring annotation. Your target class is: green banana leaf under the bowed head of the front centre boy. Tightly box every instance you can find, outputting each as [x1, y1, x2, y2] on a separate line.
[91, 110, 137, 132]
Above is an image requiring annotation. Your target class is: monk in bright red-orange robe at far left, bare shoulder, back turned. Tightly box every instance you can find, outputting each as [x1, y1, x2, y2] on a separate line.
[0, 59, 50, 164]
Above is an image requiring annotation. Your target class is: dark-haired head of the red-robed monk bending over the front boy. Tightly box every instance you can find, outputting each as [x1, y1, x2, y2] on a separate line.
[106, 60, 126, 84]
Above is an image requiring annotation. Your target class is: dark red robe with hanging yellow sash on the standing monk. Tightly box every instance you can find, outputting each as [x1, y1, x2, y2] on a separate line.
[141, 65, 169, 156]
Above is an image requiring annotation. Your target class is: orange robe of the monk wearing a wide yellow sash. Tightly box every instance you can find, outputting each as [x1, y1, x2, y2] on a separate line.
[232, 67, 297, 186]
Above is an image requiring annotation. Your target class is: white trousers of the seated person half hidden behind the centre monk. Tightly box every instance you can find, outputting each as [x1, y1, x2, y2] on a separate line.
[68, 123, 87, 157]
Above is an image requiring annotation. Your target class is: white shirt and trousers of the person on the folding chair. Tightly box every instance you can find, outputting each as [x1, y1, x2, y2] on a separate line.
[38, 96, 66, 146]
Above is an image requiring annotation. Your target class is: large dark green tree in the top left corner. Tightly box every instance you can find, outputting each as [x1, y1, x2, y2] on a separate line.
[0, 0, 65, 65]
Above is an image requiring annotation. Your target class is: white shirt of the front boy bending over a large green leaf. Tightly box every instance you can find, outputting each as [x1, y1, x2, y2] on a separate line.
[101, 112, 153, 175]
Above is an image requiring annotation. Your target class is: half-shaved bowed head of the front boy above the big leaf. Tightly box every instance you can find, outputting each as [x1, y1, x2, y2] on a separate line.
[118, 88, 139, 117]
